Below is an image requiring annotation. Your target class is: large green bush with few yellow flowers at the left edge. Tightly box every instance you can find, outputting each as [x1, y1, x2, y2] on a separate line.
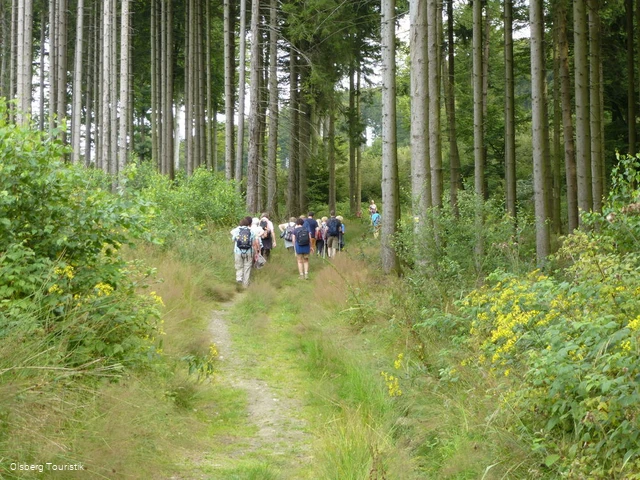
[0, 109, 158, 366]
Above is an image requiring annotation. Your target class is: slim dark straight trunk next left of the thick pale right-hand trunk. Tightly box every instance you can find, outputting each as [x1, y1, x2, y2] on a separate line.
[504, 0, 517, 219]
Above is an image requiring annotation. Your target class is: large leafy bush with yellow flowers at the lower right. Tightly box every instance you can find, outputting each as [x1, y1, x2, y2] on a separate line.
[464, 233, 640, 478]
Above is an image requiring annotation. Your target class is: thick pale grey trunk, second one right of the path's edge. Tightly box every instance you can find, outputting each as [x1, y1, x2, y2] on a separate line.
[409, 1, 431, 225]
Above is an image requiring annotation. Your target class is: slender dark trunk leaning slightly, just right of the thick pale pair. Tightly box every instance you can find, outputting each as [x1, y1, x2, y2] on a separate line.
[444, 0, 462, 216]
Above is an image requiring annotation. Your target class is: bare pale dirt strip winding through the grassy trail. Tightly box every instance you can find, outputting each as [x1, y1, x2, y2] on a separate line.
[209, 299, 310, 463]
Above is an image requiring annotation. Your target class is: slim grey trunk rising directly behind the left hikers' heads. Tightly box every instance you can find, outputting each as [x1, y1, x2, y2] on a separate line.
[267, 0, 279, 218]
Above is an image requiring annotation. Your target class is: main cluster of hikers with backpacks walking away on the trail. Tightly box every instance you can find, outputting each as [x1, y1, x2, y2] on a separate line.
[231, 211, 345, 288]
